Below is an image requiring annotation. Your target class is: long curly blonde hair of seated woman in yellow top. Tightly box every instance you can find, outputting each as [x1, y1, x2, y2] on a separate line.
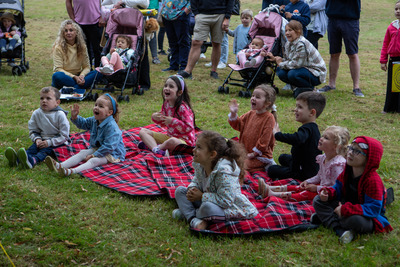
[53, 19, 87, 59]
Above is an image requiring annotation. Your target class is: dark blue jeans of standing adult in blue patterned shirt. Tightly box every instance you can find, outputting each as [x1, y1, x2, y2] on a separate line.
[163, 13, 190, 70]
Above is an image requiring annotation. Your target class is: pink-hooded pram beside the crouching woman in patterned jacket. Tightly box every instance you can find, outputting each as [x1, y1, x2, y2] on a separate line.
[218, 8, 282, 97]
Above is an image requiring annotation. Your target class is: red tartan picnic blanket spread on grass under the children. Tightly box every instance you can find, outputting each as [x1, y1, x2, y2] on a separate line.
[55, 124, 316, 235]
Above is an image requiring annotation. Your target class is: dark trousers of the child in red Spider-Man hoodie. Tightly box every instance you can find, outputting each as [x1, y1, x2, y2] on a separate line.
[313, 196, 374, 234]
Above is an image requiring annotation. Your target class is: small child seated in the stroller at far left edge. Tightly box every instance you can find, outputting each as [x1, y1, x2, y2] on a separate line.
[0, 12, 21, 57]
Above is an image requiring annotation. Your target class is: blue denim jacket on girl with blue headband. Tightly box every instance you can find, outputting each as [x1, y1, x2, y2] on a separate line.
[71, 116, 126, 161]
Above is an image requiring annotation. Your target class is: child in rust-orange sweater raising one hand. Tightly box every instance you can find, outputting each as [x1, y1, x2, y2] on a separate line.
[228, 84, 276, 175]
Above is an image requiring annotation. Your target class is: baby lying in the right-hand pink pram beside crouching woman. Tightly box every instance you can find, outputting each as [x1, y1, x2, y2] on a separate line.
[237, 37, 266, 68]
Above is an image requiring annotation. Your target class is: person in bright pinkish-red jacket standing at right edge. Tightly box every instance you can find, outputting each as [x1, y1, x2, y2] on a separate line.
[380, 0, 400, 113]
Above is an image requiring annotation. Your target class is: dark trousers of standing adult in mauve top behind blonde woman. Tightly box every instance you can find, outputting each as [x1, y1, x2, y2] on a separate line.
[79, 23, 103, 66]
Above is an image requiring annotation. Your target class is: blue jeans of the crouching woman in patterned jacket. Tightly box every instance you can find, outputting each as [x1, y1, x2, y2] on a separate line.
[276, 67, 321, 88]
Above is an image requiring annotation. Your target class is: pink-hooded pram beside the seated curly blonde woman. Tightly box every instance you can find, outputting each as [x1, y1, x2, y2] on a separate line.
[88, 8, 145, 102]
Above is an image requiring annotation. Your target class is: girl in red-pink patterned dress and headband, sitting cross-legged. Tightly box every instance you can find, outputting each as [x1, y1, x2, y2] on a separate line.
[138, 75, 196, 156]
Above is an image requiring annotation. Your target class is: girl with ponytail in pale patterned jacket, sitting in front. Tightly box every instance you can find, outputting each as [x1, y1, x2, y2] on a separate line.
[172, 131, 258, 230]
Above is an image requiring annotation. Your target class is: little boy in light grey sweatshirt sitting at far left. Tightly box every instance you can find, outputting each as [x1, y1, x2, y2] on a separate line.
[5, 86, 70, 169]
